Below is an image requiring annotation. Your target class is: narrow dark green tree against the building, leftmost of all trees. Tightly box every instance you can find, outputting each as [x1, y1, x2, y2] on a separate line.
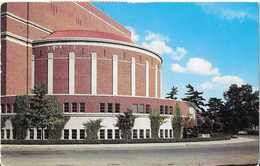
[11, 95, 31, 139]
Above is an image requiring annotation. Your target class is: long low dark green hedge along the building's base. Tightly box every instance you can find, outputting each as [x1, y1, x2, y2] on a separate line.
[1, 136, 231, 145]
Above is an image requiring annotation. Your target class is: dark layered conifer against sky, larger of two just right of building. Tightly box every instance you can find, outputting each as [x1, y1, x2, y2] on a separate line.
[182, 84, 205, 112]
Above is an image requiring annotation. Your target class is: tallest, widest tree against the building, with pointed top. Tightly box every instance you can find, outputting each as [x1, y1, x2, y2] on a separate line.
[28, 83, 63, 139]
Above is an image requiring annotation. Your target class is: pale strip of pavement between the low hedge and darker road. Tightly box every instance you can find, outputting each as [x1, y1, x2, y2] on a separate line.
[1, 137, 257, 151]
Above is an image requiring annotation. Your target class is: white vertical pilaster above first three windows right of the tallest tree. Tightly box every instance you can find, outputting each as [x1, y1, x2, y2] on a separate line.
[69, 52, 75, 94]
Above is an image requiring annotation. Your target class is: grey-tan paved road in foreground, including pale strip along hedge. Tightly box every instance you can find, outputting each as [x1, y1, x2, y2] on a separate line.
[2, 137, 258, 166]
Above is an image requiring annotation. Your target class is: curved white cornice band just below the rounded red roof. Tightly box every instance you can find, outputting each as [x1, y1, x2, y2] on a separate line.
[33, 37, 162, 63]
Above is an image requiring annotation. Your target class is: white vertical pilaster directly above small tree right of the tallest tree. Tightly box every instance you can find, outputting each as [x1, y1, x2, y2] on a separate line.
[91, 53, 97, 95]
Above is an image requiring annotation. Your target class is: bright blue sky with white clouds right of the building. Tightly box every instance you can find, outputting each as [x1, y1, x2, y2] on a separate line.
[91, 3, 259, 100]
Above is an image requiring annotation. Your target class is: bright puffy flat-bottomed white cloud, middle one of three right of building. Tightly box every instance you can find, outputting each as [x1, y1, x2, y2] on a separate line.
[172, 58, 219, 75]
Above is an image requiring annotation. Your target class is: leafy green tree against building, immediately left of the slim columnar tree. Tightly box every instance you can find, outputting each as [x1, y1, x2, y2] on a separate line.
[149, 110, 166, 138]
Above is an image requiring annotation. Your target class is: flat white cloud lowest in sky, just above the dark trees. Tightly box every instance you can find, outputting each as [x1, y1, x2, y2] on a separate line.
[199, 75, 244, 89]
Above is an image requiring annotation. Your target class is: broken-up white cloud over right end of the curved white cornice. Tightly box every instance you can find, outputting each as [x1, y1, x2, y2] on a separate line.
[142, 31, 188, 60]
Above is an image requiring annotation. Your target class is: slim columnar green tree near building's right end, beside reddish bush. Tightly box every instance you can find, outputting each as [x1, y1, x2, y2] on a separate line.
[172, 103, 183, 139]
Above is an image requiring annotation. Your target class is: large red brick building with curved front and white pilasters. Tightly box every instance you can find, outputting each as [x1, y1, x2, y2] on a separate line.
[1, 2, 194, 139]
